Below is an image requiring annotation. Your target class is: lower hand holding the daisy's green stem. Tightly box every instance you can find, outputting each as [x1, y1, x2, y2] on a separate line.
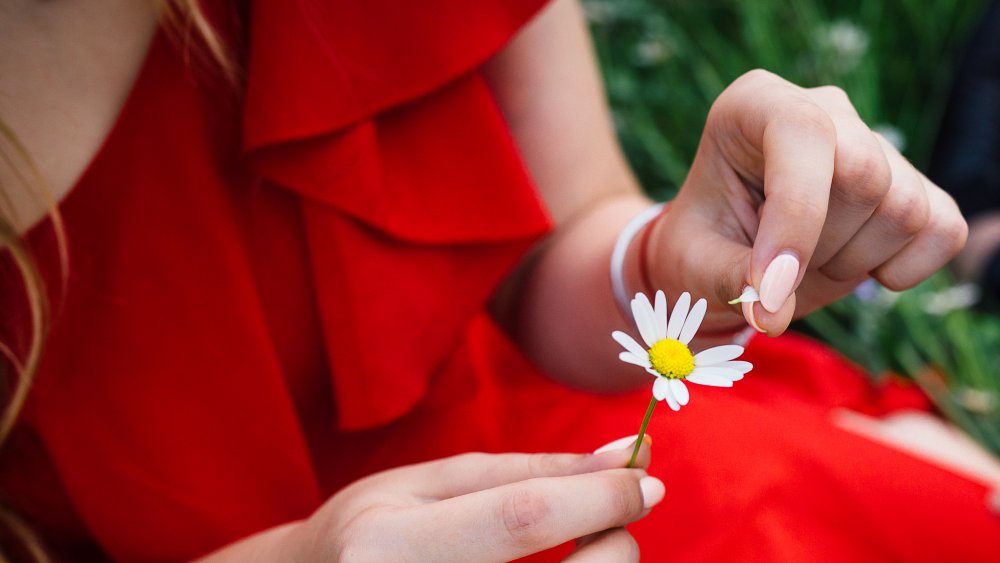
[199, 440, 664, 562]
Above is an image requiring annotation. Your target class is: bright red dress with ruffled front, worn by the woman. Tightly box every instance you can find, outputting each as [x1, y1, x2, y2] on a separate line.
[0, 0, 1000, 561]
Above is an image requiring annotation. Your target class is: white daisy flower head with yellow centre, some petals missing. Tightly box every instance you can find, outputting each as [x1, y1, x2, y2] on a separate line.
[611, 291, 753, 411]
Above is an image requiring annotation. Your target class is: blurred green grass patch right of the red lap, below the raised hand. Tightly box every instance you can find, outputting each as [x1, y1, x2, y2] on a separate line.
[804, 270, 1000, 457]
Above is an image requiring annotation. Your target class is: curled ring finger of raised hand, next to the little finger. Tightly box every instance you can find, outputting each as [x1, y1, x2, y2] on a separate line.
[820, 134, 931, 281]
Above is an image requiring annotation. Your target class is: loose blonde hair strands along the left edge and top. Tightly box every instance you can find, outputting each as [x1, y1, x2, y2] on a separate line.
[0, 0, 234, 562]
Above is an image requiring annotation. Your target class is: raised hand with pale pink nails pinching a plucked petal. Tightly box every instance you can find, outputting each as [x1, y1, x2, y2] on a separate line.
[647, 70, 967, 335]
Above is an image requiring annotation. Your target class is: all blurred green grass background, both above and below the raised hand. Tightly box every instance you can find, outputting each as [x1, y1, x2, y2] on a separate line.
[583, 0, 1000, 457]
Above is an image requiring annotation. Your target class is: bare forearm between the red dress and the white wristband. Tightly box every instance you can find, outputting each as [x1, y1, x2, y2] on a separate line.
[494, 190, 651, 391]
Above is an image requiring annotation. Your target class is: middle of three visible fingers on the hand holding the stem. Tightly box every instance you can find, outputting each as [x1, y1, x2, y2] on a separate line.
[390, 469, 664, 561]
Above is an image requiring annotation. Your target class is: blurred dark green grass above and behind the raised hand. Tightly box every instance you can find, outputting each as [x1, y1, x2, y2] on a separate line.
[583, 0, 988, 198]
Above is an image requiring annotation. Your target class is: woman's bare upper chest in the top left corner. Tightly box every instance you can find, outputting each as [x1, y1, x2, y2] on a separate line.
[0, 0, 157, 231]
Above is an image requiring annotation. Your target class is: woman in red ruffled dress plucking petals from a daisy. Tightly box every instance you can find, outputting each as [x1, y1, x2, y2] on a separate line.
[0, 0, 996, 561]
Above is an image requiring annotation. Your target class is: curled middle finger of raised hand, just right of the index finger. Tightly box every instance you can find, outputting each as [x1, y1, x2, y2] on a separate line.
[807, 86, 902, 268]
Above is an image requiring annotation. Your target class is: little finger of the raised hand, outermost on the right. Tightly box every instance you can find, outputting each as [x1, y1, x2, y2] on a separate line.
[872, 180, 969, 291]
